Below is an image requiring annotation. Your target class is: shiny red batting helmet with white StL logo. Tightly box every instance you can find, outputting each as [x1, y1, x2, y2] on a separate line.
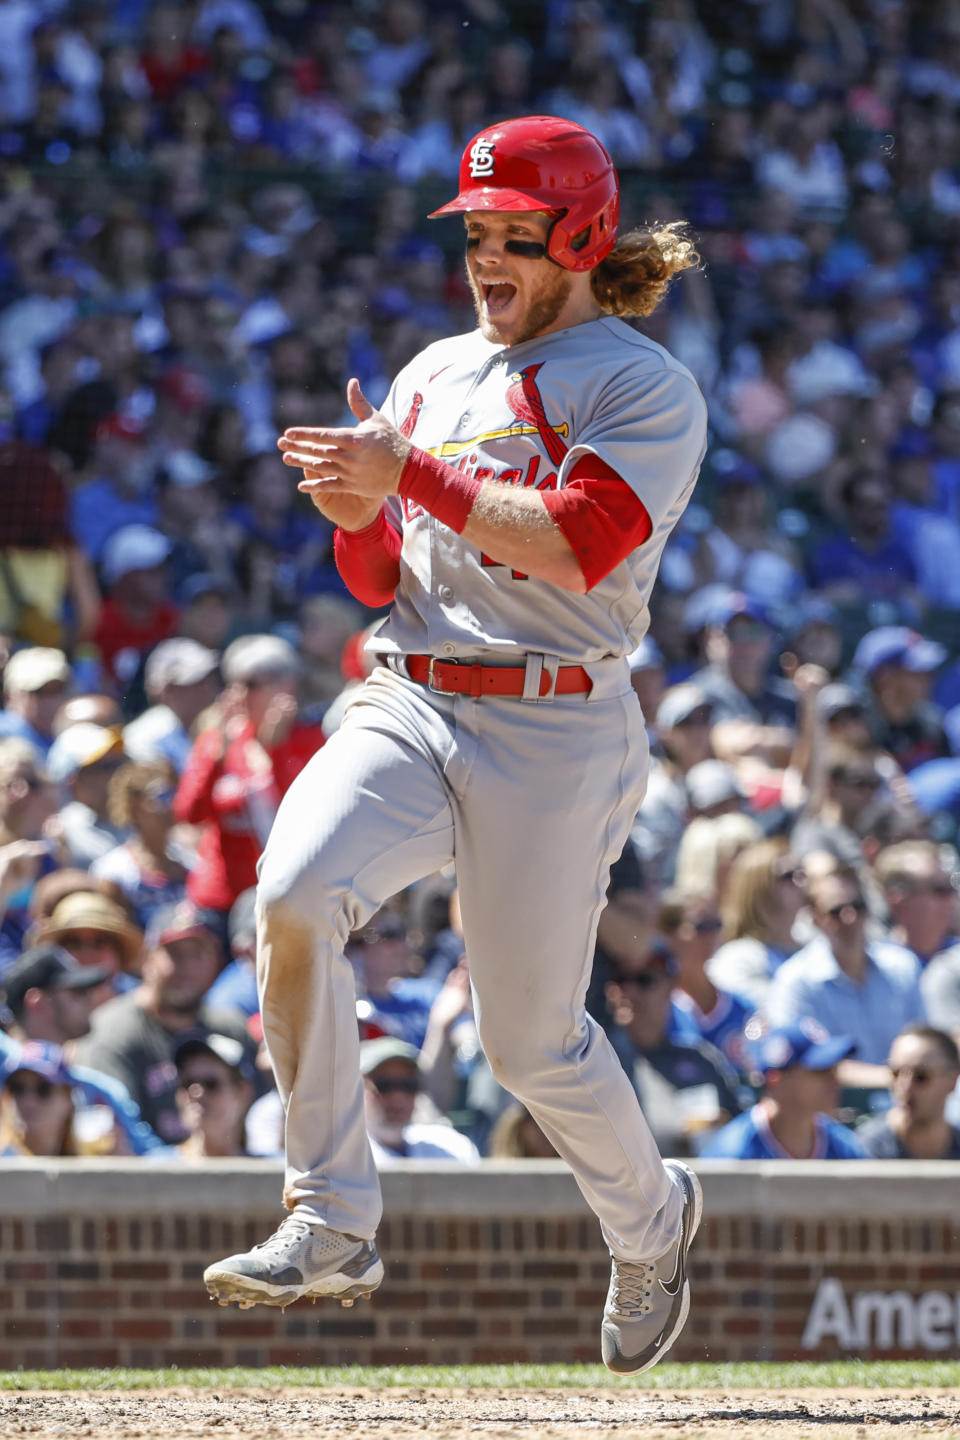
[432, 115, 620, 271]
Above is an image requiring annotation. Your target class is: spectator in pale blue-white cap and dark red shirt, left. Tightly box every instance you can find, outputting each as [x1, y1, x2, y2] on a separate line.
[94, 524, 178, 693]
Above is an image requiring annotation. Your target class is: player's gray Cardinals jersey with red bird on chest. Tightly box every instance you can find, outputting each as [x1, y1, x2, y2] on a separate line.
[371, 317, 707, 662]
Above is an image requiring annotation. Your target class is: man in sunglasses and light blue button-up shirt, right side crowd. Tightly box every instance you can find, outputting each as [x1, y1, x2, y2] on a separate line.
[766, 865, 927, 1089]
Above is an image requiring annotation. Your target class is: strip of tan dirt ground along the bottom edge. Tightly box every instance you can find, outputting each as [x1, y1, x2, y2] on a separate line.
[0, 1388, 960, 1440]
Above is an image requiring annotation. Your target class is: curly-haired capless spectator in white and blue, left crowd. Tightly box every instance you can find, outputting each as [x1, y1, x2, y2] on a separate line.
[91, 760, 194, 927]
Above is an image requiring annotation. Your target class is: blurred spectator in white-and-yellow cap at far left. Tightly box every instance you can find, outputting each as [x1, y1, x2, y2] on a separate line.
[47, 720, 127, 870]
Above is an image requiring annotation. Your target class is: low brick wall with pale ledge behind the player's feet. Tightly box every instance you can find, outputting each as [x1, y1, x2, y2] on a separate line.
[0, 1161, 960, 1369]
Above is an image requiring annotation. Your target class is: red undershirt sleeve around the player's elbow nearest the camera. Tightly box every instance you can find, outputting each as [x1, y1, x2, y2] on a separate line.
[541, 455, 653, 590]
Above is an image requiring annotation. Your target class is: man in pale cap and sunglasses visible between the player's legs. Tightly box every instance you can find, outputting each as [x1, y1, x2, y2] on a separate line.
[360, 1035, 479, 1165]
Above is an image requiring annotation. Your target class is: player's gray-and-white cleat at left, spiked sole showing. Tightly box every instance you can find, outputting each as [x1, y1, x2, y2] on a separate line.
[203, 1215, 383, 1309]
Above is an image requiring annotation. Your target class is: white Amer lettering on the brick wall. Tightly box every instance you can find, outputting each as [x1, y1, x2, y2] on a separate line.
[800, 1276, 960, 1351]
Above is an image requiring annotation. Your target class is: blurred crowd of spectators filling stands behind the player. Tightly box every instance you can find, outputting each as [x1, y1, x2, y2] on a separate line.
[0, 0, 960, 1162]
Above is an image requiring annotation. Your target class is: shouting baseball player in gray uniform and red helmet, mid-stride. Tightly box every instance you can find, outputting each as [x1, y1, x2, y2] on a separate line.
[204, 117, 707, 1372]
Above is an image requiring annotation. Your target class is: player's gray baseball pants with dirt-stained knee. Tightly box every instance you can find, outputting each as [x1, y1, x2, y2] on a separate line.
[258, 661, 681, 1260]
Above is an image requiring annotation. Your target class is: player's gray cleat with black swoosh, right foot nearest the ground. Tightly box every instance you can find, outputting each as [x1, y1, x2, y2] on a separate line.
[600, 1161, 704, 1375]
